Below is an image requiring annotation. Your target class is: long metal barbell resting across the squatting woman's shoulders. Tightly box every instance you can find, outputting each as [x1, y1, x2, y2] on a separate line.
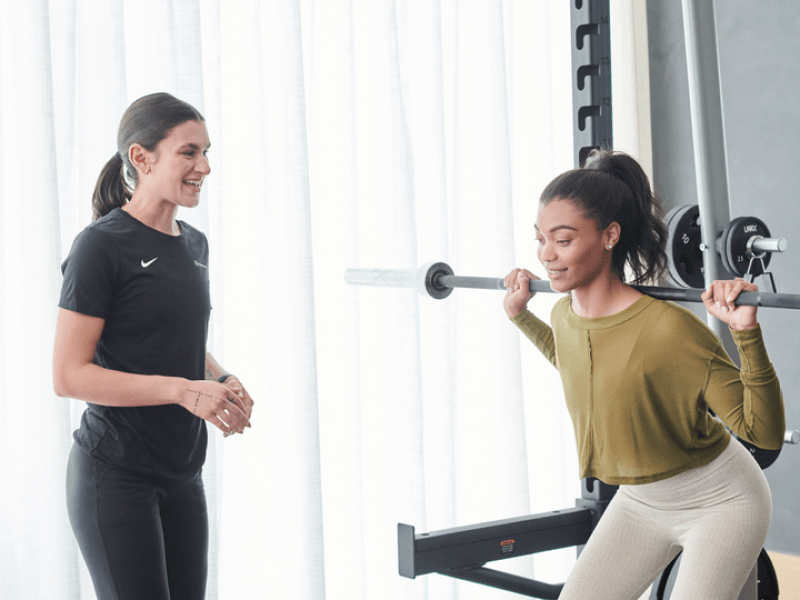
[344, 262, 800, 309]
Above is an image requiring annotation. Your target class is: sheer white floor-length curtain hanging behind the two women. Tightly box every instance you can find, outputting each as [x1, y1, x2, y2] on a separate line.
[0, 0, 644, 600]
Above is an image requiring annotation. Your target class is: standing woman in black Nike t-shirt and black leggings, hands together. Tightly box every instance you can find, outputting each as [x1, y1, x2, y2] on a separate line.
[53, 93, 253, 600]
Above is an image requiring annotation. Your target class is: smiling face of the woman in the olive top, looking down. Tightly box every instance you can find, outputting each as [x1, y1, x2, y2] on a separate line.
[536, 198, 619, 292]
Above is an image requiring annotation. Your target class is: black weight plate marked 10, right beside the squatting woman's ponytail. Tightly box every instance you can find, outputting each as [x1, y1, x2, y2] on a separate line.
[666, 204, 705, 289]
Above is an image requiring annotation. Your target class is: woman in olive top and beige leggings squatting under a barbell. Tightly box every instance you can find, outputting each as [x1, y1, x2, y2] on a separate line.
[504, 151, 785, 600]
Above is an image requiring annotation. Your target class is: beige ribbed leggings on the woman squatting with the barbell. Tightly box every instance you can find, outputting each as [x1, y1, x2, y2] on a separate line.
[559, 441, 772, 600]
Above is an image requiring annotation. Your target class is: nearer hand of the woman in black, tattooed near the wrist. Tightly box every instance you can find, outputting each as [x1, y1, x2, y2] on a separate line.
[179, 380, 250, 434]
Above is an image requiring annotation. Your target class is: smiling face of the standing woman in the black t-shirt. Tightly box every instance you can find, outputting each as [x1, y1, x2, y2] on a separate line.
[137, 121, 211, 208]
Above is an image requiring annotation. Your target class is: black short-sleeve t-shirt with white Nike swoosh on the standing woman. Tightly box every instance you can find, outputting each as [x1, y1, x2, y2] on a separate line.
[58, 209, 211, 479]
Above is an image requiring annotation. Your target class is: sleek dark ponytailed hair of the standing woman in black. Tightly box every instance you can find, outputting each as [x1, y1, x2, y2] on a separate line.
[92, 92, 205, 220]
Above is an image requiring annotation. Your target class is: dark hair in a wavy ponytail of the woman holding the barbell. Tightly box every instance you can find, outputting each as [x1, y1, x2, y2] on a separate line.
[541, 150, 667, 284]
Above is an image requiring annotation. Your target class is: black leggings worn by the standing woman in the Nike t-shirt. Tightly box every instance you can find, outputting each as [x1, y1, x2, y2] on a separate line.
[67, 445, 208, 600]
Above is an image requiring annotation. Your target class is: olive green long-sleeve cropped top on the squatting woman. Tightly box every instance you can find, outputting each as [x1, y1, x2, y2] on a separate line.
[511, 296, 786, 485]
